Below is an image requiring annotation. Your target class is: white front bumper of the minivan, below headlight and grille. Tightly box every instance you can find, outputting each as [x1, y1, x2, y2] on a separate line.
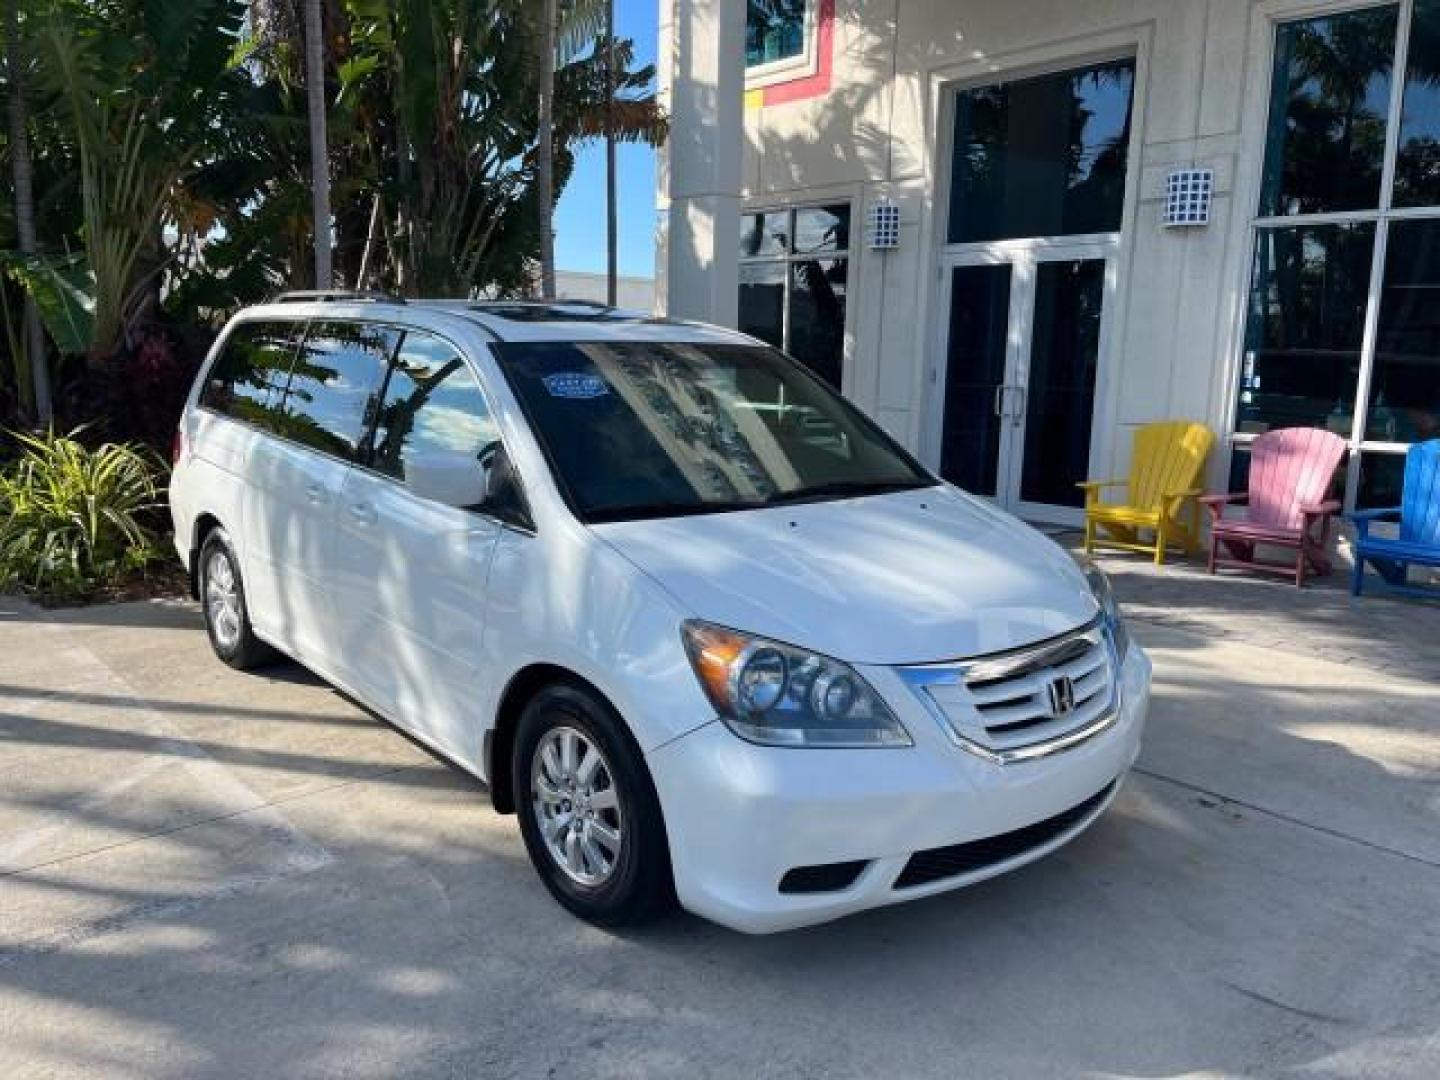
[649, 645, 1151, 933]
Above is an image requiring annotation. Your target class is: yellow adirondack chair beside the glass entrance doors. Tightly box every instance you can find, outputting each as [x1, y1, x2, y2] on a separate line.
[1080, 420, 1215, 566]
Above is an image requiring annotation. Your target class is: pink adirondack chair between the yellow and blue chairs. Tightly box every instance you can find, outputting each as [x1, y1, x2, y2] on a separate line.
[1200, 428, 1345, 586]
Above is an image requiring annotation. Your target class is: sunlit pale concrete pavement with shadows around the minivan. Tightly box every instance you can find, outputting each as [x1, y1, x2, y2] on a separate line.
[0, 570, 1440, 1077]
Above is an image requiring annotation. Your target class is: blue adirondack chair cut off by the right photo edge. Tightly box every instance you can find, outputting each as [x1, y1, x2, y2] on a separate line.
[1351, 439, 1440, 599]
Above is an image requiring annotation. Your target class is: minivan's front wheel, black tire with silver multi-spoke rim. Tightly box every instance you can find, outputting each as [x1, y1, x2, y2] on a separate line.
[511, 684, 674, 926]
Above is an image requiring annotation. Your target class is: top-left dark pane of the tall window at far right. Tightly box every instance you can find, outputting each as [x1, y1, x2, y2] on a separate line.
[1260, 6, 1398, 216]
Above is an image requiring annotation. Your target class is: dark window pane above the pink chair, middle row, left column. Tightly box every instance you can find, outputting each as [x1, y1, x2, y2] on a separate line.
[1236, 223, 1375, 435]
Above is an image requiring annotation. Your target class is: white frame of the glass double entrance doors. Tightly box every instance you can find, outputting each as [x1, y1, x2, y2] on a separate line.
[924, 233, 1120, 526]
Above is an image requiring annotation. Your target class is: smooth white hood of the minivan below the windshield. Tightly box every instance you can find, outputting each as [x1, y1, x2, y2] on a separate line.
[595, 485, 1097, 664]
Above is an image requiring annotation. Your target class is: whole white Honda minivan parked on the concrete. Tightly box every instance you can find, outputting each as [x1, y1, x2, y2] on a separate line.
[170, 294, 1151, 933]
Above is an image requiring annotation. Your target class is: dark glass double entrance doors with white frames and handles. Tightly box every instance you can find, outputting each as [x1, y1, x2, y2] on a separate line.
[937, 243, 1115, 524]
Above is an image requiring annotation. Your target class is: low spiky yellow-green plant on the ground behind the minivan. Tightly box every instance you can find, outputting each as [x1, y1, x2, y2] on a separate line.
[0, 432, 164, 596]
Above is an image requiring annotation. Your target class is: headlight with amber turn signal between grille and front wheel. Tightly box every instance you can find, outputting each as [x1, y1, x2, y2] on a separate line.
[681, 621, 913, 747]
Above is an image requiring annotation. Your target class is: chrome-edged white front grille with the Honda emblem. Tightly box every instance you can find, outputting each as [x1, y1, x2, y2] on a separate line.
[900, 621, 1116, 763]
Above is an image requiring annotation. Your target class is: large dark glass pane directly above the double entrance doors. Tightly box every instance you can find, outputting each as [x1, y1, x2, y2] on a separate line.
[949, 60, 1135, 243]
